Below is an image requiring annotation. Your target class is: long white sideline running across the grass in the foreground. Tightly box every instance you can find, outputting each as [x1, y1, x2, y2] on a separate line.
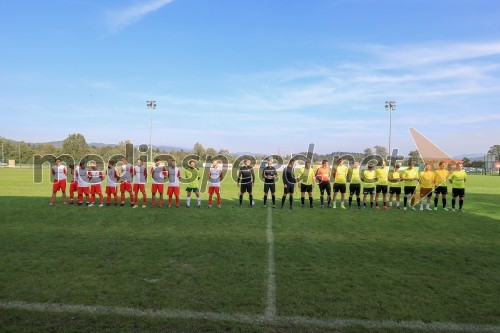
[0, 301, 500, 333]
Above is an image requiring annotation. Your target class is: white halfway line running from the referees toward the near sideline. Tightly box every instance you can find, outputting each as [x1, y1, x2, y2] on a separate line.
[265, 207, 276, 320]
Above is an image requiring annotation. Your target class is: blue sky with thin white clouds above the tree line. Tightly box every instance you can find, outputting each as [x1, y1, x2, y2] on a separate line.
[0, 0, 500, 155]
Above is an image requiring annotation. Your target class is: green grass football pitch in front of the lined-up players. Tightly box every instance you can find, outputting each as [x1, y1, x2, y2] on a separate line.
[0, 169, 500, 332]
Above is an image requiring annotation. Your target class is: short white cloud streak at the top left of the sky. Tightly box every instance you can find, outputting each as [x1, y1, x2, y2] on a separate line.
[106, 0, 173, 35]
